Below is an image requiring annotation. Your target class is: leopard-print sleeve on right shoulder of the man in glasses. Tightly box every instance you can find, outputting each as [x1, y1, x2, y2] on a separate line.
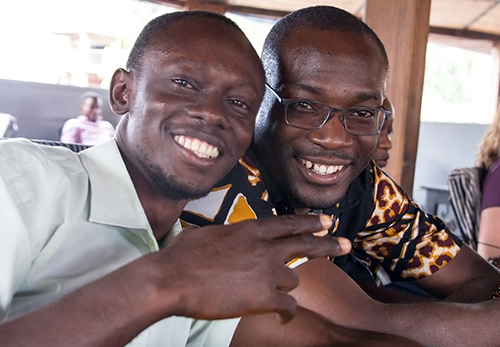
[353, 167, 462, 281]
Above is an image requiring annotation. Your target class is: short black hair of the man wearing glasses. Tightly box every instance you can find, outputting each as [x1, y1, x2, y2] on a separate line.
[261, 6, 389, 87]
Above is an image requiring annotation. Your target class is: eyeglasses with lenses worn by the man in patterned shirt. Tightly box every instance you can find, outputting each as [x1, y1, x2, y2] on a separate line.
[266, 83, 391, 136]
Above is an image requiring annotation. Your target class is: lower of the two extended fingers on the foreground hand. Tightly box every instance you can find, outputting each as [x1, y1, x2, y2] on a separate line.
[274, 234, 352, 261]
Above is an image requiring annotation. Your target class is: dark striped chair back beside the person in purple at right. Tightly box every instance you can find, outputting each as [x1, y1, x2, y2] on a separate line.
[448, 167, 486, 250]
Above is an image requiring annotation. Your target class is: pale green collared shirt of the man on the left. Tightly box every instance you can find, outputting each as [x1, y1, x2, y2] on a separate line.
[0, 139, 238, 347]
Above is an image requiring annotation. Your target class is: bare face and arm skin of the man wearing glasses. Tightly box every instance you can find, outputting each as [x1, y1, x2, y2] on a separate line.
[255, 27, 500, 347]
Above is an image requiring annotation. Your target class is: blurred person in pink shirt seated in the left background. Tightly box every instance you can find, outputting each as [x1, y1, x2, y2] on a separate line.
[61, 92, 115, 146]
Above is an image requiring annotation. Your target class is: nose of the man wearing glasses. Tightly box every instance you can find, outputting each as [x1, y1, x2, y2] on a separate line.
[308, 113, 354, 150]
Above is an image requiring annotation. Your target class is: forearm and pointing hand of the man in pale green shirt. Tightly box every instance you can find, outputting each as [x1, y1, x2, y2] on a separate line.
[0, 216, 350, 347]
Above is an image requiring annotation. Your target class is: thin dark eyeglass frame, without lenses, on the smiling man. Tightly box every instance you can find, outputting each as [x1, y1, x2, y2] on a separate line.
[266, 83, 391, 136]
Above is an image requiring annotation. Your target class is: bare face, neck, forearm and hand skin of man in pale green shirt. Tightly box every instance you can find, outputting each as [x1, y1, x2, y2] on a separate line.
[0, 17, 350, 347]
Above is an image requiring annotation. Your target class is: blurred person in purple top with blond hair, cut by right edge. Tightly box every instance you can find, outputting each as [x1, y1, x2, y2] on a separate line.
[476, 103, 500, 267]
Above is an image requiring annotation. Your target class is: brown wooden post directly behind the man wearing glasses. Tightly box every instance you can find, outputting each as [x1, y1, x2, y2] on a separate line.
[364, 0, 431, 196]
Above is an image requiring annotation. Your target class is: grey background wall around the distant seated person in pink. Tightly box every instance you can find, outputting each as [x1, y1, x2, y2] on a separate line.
[0, 79, 120, 140]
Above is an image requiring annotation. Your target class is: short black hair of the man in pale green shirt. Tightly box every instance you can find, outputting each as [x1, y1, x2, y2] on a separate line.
[126, 10, 244, 71]
